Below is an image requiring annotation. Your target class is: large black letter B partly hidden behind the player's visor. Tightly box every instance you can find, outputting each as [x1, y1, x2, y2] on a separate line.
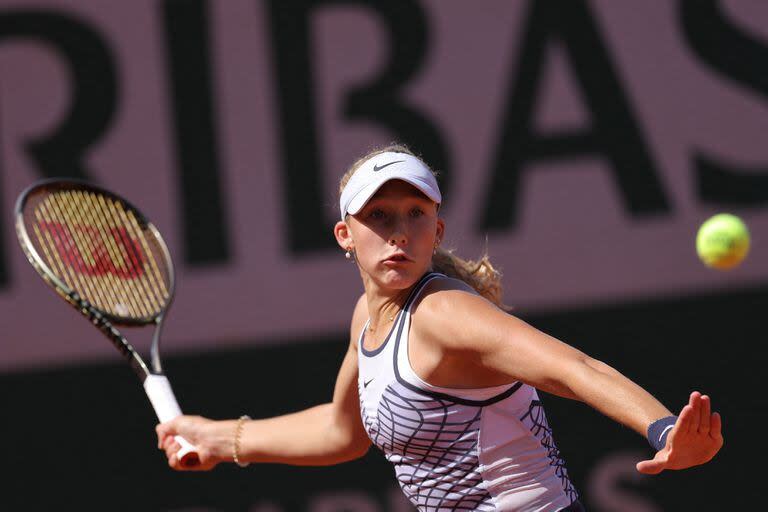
[268, 0, 450, 253]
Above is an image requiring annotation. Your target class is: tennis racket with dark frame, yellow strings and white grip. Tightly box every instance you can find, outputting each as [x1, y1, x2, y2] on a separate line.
[15, 179, 199, 466]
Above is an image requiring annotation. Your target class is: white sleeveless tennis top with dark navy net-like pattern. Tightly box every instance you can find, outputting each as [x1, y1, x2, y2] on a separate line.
[358, 273, 578, 512]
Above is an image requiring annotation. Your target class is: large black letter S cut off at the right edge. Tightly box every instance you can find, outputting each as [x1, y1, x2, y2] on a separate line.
[680, 0, 768, 206]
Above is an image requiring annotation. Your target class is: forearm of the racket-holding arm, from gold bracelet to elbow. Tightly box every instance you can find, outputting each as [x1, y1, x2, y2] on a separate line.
[234, 403, 369, 466]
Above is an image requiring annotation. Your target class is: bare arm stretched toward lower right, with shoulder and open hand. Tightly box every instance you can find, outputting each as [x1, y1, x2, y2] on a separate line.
[414, 280, 722, 472]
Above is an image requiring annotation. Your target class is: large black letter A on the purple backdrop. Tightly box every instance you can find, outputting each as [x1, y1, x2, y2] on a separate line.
[481, 0, 670, 230]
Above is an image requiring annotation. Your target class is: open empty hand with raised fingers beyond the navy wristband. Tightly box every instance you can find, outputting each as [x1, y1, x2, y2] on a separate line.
[636, 391, 723, 475]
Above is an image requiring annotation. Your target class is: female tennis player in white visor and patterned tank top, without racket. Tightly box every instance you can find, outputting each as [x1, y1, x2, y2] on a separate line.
[157, 146, 723, 511]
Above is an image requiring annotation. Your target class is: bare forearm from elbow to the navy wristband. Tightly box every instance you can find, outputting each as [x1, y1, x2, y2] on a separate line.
[554, 356, 672, 437]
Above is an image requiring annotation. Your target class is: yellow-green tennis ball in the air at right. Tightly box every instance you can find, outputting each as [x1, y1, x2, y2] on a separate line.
[696, 213, 749, 270]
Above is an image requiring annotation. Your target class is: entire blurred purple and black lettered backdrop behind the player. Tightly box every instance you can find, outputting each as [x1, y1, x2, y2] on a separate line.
[0, 0, 768, 512]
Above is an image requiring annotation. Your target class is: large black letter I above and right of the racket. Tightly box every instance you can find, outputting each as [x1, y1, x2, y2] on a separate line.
[162, 0, 229, 265]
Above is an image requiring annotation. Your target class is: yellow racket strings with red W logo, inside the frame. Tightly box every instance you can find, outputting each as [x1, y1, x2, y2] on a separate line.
[24, 190, 171, 319]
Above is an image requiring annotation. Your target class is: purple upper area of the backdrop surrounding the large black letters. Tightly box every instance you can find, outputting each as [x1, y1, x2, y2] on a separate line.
[0, 0, 768, 368]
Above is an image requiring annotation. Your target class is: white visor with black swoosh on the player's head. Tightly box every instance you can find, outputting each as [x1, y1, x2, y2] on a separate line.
[339, 152, 443, 220]
